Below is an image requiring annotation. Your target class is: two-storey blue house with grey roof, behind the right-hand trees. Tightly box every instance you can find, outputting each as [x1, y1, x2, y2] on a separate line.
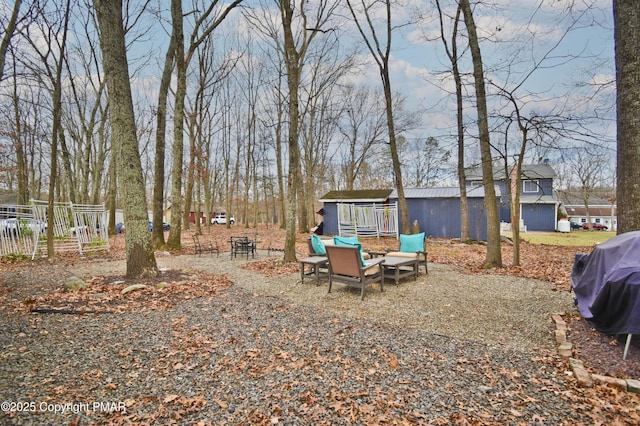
[465, 162, 560, 231]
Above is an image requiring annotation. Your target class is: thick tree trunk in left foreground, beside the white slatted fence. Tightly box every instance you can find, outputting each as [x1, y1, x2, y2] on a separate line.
[93, 0, 158, 278]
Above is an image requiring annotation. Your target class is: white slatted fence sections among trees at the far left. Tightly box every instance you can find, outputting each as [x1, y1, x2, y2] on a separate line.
[0, 200, 109, 259]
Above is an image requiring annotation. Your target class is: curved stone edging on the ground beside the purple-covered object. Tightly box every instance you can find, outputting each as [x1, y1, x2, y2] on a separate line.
[551, 314, 640, 393]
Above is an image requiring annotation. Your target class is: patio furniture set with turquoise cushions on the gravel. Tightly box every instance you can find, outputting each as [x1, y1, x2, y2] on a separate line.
[299, 233, 428, 300]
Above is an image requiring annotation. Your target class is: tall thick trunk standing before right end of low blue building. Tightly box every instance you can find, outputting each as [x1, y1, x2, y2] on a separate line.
[460, 0, 502, 268]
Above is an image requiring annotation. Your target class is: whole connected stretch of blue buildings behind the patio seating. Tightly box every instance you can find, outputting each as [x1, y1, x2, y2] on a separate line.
[320, 163, 559, 241]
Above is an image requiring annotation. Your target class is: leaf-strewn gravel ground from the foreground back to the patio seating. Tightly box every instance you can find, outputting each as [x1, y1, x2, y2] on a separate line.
[0, 254, 638, 425]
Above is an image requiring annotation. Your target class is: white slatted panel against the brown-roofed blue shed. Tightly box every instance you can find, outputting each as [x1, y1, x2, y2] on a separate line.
[337, 203, 398, 237]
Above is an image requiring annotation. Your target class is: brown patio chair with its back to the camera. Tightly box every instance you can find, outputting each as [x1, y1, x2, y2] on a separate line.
[325, 245, 384, 300]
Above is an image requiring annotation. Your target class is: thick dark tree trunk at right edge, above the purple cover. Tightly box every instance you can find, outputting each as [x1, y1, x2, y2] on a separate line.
[613, 0, 640, 234]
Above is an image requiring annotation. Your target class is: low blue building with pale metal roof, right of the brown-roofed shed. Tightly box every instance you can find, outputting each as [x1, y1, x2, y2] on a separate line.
[389, 186, 500, 241]
